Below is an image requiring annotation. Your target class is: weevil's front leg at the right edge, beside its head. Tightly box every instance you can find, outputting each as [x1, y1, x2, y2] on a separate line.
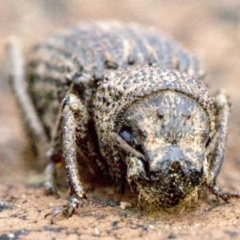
[206, 91, 240, 202]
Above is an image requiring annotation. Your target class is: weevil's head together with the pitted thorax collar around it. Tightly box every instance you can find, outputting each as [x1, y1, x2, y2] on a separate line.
[94, 66, 215, 208]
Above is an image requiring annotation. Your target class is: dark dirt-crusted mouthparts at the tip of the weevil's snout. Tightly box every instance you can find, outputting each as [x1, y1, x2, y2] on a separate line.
[135, 156, 203, 208]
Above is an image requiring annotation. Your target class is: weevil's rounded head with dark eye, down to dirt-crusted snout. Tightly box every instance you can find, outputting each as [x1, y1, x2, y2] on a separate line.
[119, 90, 210, 207]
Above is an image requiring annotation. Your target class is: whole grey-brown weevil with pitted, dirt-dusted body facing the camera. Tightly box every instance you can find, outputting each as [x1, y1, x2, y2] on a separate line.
[6, 22, 240, 217]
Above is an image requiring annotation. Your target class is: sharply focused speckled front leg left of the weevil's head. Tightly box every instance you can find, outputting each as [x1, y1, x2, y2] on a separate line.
[47, 94, 86, 221]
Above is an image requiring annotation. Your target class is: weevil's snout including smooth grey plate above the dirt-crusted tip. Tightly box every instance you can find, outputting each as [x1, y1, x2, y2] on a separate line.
[131, 145, 203, 207]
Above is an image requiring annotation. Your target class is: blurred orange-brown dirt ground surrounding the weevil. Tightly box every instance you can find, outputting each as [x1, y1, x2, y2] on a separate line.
[0, 0, 240, 240]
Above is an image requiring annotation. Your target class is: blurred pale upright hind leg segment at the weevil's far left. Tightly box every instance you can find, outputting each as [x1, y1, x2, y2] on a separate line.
[7, 37, 49, 146]
